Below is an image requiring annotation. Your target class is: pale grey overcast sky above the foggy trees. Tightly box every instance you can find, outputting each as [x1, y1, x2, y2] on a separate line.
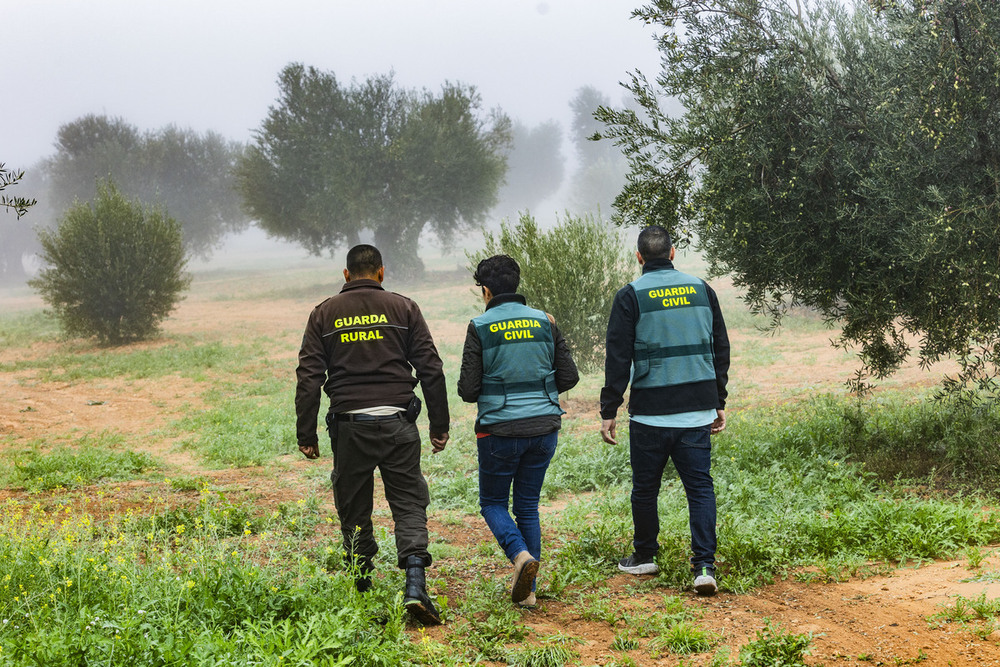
[7, 0, 659, 169]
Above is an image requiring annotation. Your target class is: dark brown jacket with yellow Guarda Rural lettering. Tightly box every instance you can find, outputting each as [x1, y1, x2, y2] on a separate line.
[295, 279, 449, 447]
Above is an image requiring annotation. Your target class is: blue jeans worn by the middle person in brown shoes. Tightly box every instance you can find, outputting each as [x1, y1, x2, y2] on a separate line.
[478, 431, 559, 562]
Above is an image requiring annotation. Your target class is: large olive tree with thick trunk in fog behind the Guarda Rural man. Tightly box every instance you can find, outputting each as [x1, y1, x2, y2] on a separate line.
[238, 63, 510, 276]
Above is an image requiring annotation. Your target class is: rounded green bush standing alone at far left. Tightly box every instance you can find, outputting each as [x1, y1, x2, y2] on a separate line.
[29, 180, 190, 344]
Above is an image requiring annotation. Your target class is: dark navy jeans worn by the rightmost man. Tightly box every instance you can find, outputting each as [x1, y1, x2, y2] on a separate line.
[629, 421, 715, 571]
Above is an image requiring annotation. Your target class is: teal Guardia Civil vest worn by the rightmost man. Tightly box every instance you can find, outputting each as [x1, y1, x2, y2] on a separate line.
[630, 269, 715, 389]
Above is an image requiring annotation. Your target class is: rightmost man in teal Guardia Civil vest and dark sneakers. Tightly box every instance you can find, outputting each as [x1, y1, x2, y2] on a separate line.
[601, 226, 729, 595]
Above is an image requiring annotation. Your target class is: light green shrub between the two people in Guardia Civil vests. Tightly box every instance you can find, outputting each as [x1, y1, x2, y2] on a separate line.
[469, 213, 635, 371]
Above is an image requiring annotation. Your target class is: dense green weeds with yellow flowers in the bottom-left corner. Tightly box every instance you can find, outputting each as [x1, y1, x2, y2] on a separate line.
[0, 500, 416, 665]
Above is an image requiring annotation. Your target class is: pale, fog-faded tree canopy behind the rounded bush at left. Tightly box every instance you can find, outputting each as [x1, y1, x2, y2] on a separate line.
[47, 114, 248, 257]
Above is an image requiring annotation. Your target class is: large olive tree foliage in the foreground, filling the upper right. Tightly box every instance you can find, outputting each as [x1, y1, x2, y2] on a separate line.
[599, 0, 1000, 390]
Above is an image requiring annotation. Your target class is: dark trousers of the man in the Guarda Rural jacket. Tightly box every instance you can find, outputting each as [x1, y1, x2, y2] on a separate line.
[327, 415, 431, 569]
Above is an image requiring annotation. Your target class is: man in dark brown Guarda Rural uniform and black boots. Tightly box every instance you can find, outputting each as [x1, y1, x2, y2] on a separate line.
[295, 245, 449, 625]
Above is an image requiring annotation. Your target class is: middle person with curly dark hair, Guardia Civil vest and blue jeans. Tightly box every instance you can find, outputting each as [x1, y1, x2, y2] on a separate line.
[458, 255, 580, 606]
